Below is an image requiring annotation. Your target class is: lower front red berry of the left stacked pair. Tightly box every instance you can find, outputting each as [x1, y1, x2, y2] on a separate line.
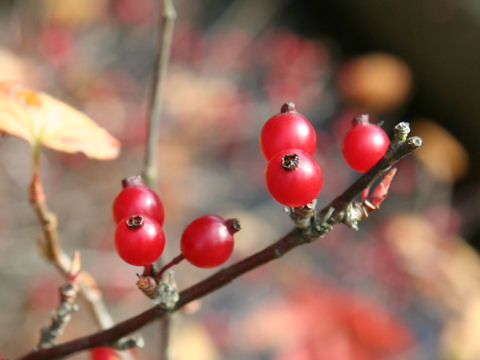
[115, 215, 165, 266]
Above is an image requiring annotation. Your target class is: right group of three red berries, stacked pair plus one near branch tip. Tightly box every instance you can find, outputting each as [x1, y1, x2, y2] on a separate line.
[260, 102, 390, 207]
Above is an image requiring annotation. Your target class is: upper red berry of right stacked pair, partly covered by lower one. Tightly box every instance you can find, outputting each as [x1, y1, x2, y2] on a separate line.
[260, 102, 317, 161]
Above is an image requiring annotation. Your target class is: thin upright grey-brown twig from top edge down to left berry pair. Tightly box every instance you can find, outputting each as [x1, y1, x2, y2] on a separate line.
[143, 0, 177, 189]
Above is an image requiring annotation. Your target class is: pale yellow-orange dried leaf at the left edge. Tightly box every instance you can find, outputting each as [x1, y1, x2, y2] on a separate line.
[0, 82, 120, 160]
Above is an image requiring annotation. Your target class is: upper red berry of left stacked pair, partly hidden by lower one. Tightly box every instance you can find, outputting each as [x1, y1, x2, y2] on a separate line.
[112, 176, 165, 226]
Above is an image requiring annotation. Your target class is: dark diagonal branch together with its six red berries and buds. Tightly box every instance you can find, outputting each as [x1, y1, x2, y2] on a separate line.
[14, 93, 422, 360]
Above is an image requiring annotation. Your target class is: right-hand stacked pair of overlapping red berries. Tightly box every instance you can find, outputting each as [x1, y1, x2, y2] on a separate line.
[260, 102, 323, 207]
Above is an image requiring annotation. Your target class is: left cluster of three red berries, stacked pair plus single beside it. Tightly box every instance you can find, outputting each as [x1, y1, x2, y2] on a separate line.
[113, 176, 240, 268]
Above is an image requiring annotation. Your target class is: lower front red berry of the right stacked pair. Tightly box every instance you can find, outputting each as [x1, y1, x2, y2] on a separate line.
[265, 149, 323, 207]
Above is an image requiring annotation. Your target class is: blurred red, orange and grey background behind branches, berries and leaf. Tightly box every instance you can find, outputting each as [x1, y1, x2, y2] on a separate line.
[0, 0, 480, 360]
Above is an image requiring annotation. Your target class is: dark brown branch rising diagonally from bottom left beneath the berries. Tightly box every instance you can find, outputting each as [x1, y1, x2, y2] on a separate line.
[19, 124, 422, 360]
